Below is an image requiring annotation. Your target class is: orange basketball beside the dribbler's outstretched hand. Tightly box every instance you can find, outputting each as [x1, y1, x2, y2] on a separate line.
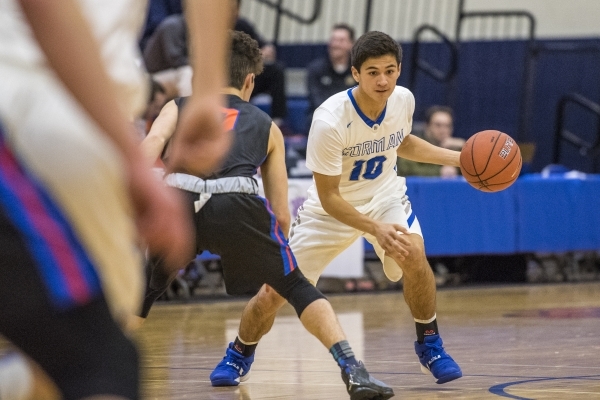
[460, 130, 523, 192]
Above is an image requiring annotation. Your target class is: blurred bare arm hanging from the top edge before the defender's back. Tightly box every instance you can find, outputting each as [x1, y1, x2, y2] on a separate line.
[169, 0, 232, 176]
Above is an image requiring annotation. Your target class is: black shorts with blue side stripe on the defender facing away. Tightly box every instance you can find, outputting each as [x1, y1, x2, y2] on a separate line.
[186, 192, 303, 295]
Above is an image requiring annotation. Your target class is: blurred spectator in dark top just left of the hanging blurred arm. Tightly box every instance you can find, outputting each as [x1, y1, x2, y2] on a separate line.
[143, 14, 192, 98]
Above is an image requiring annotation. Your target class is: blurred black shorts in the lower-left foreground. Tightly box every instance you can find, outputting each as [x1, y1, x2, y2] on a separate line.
[0, 203, 139, 400]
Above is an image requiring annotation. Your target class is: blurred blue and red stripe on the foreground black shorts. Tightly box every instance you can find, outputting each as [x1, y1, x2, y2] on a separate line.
[0, 127, 101, 309]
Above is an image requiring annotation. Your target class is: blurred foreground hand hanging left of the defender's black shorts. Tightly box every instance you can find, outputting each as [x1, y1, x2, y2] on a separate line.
[128, 157, 194, 270]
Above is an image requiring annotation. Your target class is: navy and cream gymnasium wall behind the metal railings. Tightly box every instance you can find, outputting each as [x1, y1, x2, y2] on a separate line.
[241, 0, 600, 171]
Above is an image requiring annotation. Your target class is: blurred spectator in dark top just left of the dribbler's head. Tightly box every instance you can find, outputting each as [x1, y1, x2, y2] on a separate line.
[307, 24, 356, 127]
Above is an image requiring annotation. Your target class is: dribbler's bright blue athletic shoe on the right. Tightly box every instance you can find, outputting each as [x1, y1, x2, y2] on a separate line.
[415, 335, 462, 383]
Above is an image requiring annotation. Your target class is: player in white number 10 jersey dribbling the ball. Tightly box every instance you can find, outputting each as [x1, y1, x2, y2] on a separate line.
[211, 32, 462, 383]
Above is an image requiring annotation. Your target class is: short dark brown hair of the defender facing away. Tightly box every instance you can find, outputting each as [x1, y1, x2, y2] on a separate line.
[229, 31, 263, 89]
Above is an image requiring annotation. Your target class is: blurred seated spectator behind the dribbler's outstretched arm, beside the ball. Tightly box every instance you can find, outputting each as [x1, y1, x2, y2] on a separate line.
[398, 106, 465, 178]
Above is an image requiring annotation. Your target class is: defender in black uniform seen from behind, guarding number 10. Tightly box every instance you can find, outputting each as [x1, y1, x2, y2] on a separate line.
[140, 32, 394, 400]
